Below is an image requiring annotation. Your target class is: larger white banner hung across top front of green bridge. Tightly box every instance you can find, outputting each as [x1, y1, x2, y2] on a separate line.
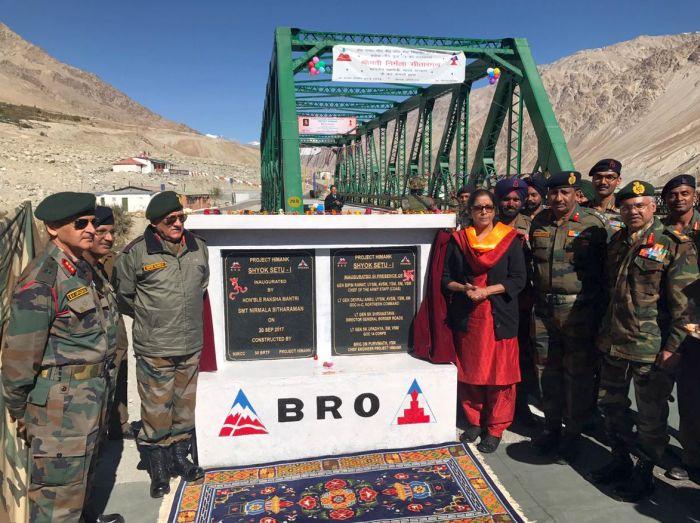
[333, 45, 466, 84]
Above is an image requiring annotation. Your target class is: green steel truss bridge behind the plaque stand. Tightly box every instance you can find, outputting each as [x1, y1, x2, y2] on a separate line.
[260, 27, 573, 213]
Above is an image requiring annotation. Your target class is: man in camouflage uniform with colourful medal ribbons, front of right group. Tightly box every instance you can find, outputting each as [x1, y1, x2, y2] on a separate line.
[592, 180, 698, 502]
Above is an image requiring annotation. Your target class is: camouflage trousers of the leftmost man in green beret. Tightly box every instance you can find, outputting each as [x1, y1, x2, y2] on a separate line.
[25, 372, 108, 523]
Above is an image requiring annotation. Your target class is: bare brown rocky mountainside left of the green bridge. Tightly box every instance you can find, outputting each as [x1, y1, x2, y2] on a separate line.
[0, 23, 260, 206]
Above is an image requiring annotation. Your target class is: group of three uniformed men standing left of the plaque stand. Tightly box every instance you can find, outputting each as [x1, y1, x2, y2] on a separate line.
[1, 191, 209, 523]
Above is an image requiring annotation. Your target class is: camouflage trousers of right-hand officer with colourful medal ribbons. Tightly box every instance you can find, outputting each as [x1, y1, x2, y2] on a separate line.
[598, 355, 673, 463]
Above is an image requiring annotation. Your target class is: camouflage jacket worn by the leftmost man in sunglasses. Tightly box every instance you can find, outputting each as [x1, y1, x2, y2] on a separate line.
[2, 242, 116, 419]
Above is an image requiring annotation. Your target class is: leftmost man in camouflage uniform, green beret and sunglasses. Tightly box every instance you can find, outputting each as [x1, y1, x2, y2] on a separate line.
[2, 193, 123, 523]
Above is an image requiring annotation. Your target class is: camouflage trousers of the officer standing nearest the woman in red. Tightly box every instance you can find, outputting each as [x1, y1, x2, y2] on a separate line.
[534, 303, 596, 435]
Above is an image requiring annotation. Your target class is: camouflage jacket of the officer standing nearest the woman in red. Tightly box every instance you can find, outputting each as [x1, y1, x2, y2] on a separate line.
[530, 205, 607, 299]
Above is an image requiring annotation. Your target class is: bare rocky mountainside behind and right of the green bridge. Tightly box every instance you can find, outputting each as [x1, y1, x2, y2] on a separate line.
[307, 33, 700, 185]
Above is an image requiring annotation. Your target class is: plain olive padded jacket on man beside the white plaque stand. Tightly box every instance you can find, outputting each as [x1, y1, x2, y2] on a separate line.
[112, 226, 209, 357]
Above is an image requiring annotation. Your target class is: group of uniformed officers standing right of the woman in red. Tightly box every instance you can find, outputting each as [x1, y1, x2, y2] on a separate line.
[456, 159, 700, 501]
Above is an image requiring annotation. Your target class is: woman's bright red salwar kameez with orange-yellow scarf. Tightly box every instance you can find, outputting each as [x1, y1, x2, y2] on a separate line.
[453, 223, 520, 438]
